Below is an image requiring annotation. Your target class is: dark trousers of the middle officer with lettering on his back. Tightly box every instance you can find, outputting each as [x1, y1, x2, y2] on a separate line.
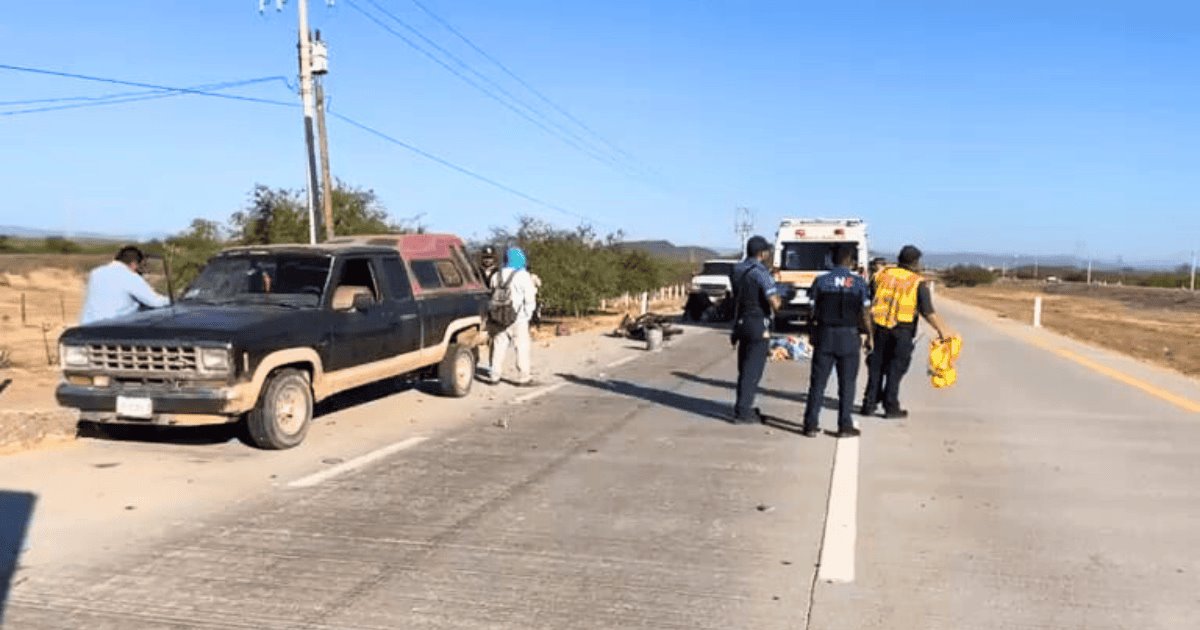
[804, 326, 863, 431]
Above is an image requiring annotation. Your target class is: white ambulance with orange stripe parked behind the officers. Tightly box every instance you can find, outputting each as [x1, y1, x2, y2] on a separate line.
[774, 218, 870, 324]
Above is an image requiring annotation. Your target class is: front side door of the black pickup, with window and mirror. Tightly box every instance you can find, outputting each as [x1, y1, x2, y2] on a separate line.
[325, 257, 396, 372]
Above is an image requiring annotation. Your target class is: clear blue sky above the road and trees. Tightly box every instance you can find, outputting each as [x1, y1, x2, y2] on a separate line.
[0, 0, 1200, 262]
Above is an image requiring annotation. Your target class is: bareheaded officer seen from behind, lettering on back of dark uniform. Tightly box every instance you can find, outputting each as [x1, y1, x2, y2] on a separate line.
[804, 244, 871, 438]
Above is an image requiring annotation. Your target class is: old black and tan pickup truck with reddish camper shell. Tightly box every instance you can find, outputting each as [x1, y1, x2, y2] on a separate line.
[58, 234, 487, 449]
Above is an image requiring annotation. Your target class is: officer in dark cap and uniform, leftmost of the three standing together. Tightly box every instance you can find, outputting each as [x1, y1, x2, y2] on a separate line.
[731, 236, 782, 424]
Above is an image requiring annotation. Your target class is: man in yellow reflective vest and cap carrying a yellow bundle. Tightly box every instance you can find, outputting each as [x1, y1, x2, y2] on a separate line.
[859, 245, 954, 419]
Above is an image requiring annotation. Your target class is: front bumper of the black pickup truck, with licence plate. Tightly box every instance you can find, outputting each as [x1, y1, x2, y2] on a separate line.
[55, 383, 246, 421]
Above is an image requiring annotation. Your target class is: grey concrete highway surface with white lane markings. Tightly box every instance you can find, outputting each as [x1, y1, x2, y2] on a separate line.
[0, 305, 1200, 630]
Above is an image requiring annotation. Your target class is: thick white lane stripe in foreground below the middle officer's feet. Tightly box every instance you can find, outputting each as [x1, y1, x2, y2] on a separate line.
[817, 438, 858, 582]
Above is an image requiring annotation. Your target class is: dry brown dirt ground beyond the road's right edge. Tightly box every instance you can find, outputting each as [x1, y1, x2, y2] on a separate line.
[938, 283, 1200, 377]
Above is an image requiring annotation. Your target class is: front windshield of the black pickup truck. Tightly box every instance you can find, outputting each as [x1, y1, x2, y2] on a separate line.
[180, 254, 330, 307]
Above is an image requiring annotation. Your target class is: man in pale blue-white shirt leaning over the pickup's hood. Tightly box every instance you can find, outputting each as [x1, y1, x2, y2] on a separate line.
[79, 247, 170, 325]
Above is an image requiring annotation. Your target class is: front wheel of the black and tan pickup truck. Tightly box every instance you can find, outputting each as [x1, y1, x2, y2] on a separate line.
[246, 370, 313, 450]
